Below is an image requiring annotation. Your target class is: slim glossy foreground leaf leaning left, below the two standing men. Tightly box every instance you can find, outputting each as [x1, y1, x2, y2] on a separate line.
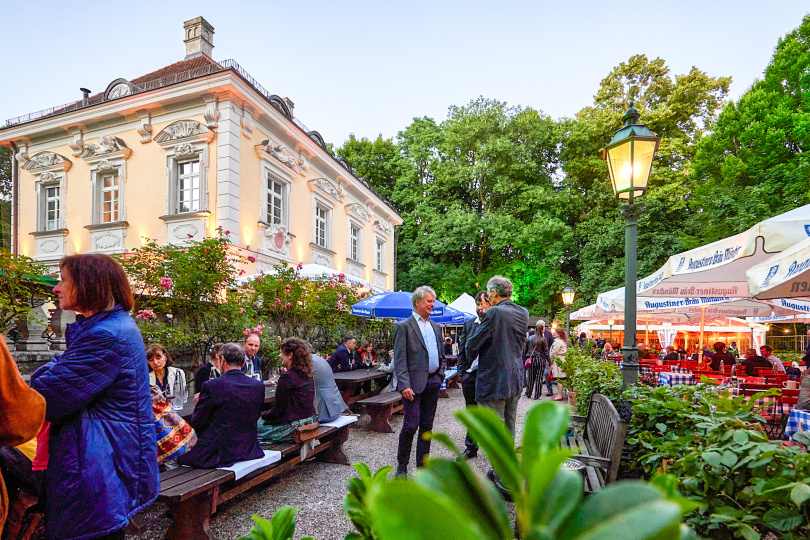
[454, 407, 523, 494]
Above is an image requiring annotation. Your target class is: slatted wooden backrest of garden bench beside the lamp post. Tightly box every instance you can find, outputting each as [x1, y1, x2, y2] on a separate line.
[584, 394, 627, 483]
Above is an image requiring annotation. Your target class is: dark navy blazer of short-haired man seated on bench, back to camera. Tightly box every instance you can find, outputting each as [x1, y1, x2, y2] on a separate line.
[177, 369, 264, 469]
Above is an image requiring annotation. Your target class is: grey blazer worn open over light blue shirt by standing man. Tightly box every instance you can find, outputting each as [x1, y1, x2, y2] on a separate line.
[394, 314, 445, 394]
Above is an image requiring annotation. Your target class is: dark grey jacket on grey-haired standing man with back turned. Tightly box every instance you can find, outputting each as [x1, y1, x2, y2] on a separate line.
[467, 300, 529, 403]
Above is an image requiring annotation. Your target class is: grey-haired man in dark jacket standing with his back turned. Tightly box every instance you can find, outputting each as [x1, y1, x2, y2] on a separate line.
[467, 276, 529, 437]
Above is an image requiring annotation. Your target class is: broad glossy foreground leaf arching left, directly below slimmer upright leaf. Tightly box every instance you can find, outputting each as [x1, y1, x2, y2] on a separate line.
[414, 458, 512, 538]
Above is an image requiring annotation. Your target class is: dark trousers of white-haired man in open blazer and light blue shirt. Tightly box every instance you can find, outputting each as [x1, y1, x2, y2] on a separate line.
[397, 373, 442, 471]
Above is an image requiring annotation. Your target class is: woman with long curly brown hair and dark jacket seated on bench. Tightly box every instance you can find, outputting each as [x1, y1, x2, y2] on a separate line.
[259, 337, 318, 444]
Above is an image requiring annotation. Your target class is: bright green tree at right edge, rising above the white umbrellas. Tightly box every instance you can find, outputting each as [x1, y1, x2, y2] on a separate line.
[691, 15, 810, 242]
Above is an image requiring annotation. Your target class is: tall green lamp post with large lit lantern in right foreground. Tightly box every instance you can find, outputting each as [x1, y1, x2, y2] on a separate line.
[602, 101, 661, 388]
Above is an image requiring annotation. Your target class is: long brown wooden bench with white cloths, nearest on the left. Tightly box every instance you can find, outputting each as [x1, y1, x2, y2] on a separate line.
[158, 425, 350, 540]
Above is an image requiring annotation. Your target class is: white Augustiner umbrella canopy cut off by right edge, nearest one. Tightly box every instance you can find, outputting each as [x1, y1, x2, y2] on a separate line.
[746, 237, 810, 298]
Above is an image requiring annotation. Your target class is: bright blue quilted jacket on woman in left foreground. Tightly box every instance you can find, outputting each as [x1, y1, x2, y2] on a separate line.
[31, 306, 160, 540]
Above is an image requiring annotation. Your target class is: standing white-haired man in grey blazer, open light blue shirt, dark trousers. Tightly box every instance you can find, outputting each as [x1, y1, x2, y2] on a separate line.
[394, 286, 444, 476]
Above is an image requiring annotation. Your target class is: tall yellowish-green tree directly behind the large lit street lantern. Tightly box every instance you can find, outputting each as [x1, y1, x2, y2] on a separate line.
[560, 55, 731, 300]
